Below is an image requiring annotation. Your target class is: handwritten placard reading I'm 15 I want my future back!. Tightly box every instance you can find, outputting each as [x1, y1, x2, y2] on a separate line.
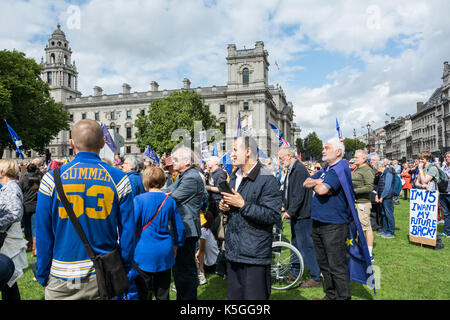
[409, 189, 439, 246]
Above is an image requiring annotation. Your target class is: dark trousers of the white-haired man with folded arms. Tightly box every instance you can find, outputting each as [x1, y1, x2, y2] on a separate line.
[312, 220, 351, 300]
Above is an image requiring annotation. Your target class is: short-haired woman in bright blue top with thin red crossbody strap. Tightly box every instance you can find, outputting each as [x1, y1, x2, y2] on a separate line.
[134, 167, 186, 300]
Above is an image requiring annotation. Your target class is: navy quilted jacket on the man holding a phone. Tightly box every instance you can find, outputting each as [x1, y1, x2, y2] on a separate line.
[225, 161, 282, 265]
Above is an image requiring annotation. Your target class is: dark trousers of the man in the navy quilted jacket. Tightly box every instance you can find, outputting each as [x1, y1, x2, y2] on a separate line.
[227, 261, 271, 300]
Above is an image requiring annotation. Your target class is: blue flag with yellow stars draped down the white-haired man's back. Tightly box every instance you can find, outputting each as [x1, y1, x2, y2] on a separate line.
[330, 160, 376, 294]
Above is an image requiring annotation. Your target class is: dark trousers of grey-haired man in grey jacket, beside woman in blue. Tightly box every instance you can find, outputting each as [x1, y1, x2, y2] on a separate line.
[172, 237, 198, 300]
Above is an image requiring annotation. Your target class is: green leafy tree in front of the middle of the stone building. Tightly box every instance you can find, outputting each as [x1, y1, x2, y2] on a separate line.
[134, 91, 218, 154]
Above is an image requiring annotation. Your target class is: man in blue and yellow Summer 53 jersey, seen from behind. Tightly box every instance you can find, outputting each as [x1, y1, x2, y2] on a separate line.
[36, 120, 136, 300]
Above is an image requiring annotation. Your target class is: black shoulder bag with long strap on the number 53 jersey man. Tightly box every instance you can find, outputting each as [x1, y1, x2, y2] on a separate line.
[53, 168, 129, 299]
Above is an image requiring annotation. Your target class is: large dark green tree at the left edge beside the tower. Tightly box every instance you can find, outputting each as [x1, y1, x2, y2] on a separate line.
[0, 50, 70, 158]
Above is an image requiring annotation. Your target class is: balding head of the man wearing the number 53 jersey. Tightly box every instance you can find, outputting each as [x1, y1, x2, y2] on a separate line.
[71, 119, 105, 153]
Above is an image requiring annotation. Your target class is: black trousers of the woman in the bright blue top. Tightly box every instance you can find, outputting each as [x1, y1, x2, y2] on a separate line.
[135, 269, 171, 300]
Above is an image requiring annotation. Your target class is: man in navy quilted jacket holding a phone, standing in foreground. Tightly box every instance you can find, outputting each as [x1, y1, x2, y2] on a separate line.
[219, 137, 282, 300]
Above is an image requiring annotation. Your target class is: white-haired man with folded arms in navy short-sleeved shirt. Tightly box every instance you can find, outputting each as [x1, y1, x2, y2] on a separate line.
[303, 139, 351, 300]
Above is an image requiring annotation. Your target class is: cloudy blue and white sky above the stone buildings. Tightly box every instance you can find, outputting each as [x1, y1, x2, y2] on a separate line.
[0, 0, 450, 140]
